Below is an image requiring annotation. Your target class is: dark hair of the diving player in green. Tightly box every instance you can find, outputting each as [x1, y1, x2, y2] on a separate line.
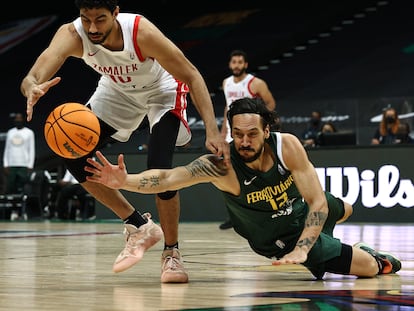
[227, 97, 278, 128]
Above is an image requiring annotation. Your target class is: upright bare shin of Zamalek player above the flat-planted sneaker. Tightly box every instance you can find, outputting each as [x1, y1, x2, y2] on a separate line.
[155, 191, 180, 245]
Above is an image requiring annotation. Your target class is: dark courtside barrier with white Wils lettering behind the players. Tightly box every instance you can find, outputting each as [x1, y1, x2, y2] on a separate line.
[96, 145, 414, 223]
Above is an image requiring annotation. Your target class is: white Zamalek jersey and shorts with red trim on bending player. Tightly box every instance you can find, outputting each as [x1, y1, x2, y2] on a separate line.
[73, 13, 191, 144]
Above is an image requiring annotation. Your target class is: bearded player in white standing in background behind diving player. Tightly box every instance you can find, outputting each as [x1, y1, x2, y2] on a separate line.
[219, 50, 276, 229]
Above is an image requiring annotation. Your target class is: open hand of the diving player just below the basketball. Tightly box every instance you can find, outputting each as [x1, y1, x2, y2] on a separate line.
[84, 151, 128, 189]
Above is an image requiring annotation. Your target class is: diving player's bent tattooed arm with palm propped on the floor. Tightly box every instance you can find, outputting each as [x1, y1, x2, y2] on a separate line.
[273, 134, 328, 265]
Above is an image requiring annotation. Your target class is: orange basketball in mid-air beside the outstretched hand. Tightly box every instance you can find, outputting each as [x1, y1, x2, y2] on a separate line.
[44, 103, 101, 159]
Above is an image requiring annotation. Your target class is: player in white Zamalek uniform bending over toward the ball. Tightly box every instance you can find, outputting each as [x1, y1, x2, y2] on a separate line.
[21, 0, 229, 283]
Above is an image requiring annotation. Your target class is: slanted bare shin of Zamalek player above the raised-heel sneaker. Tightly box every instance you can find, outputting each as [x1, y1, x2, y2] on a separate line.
[82, 181, 135, 219]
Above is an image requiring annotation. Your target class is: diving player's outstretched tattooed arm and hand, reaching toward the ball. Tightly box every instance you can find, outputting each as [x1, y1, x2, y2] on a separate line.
[85, 151, 228, 193]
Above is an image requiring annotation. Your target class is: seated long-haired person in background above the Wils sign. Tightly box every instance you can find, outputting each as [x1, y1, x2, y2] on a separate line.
[371, 107, 400, 145]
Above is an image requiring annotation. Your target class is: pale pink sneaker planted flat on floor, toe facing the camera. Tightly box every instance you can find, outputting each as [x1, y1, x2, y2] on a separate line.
[161, 248, 188, 283]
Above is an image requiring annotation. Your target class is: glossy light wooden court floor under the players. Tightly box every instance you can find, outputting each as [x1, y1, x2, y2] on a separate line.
[0, 221, 414, 311]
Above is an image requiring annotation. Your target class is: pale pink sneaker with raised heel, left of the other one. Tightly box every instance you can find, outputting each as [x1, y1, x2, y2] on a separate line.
[112, 213, 164, 272]
